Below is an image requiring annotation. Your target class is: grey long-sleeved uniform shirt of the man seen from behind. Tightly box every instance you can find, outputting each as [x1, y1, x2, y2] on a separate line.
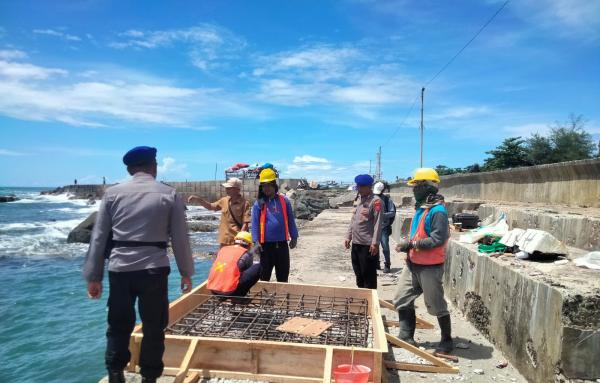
[83, 172, 194, 281]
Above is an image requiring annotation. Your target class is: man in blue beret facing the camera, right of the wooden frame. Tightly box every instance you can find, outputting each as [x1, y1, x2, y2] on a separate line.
[344, 174, 383, 289]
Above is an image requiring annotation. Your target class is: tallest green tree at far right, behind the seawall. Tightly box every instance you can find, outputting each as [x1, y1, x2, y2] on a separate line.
[549, 114, 595, 162]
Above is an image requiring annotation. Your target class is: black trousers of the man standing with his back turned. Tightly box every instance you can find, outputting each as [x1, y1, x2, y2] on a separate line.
[105, 267, 170, 378]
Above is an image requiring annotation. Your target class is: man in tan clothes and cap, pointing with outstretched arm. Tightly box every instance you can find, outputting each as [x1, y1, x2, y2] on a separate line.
[188, 178, 251, 247]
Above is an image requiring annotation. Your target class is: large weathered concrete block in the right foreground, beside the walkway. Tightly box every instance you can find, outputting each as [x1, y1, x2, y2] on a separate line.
[444, 240, 600, 382]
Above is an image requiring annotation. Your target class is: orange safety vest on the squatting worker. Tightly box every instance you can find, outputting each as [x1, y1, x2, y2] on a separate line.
[207, 245, 248, 294]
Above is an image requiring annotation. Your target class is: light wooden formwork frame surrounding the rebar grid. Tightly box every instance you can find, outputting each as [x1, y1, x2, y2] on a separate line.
[129, 282, 388, 383]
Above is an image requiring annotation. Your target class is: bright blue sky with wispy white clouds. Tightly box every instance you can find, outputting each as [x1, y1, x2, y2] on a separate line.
[0, 0, 600, 186]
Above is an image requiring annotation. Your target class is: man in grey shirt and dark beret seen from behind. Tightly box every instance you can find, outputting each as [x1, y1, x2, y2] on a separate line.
[83, 146, 194, 383]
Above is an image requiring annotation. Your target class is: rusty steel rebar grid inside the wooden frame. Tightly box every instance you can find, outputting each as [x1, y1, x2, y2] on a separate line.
[167, 290, 372, 347]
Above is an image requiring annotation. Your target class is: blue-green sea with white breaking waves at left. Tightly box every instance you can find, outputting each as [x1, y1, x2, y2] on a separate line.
[0, 187, 217, 383]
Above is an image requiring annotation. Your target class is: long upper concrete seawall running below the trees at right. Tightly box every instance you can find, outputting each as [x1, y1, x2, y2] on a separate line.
[391, 159, 600, 207]
